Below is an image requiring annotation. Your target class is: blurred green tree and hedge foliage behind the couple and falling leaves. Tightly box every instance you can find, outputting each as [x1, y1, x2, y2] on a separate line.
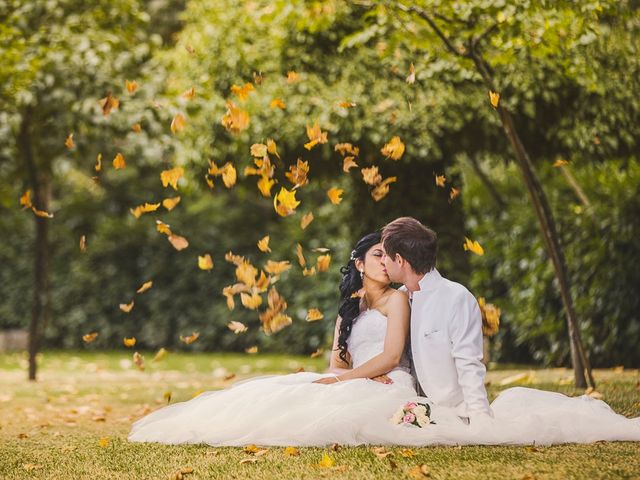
[0, 0, 640, 378]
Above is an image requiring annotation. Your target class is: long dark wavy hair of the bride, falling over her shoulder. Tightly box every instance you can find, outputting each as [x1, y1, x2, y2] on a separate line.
[338, 232, 382, 363]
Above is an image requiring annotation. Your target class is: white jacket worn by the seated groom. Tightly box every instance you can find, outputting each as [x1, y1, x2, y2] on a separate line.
[411, 268, 491, 417]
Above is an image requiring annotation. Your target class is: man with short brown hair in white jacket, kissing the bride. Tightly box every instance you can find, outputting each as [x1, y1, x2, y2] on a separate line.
[382, 217, 492, 423]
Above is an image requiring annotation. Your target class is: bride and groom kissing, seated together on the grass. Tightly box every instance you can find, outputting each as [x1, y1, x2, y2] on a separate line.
[129, 217, 640, 446]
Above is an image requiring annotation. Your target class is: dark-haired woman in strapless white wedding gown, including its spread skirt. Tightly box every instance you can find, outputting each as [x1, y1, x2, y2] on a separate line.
[129, 233, 640, 446]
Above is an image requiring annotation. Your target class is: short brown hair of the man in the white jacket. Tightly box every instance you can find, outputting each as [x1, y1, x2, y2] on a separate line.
[382, 217, 438, 273]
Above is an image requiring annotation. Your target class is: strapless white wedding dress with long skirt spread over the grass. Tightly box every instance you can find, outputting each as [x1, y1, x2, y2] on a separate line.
[129, 310, 640, 446]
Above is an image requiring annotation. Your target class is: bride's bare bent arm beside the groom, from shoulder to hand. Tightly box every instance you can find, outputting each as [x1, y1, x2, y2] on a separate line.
[336, 291, 410, 381]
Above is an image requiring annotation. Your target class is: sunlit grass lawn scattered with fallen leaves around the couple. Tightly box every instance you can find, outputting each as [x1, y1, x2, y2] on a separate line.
[0, 351, 640, 480]
